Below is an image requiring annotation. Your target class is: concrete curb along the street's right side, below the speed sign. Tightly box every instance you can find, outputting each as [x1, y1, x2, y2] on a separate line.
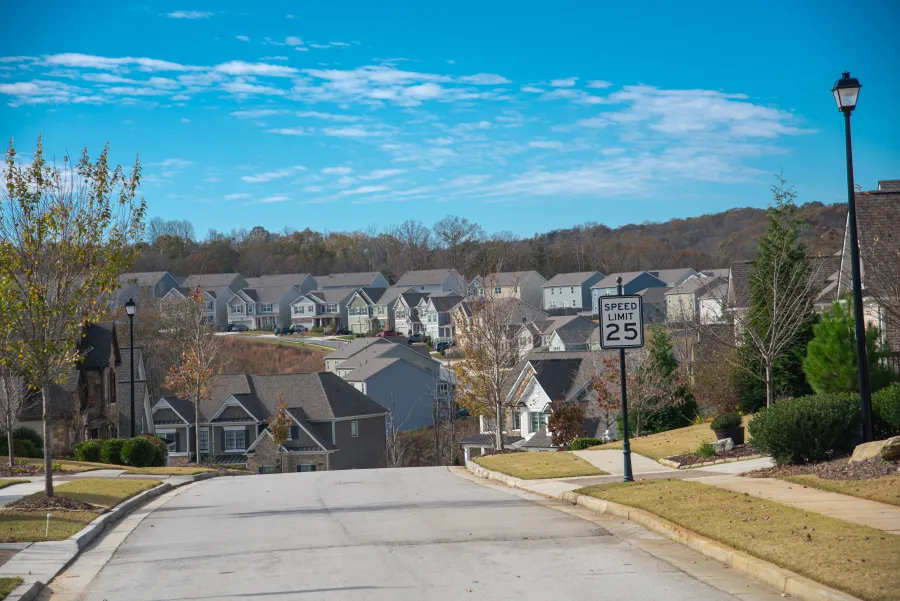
[466, 462, 860, 601]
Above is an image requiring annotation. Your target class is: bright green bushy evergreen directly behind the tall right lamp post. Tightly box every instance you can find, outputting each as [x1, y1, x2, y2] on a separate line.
[803, 301, 892, 394]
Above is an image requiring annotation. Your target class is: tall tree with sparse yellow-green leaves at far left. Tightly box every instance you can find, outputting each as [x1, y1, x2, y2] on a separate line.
[0, 139, 146, 497]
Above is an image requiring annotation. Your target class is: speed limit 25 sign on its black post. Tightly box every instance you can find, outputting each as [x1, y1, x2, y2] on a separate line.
[597, 277, 644, 482]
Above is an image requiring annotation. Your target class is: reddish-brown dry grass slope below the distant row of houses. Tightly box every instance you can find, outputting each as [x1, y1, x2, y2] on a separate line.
[224, 336, 327, 374]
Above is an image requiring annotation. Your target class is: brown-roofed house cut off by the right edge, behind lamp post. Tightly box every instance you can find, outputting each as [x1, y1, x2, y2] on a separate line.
[837, 179, 900, 350]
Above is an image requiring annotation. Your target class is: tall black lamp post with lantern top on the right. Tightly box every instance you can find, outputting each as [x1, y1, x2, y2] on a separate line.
[831, 71, 872, 442]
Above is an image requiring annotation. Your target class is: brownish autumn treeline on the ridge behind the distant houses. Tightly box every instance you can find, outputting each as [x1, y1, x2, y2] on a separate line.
[134, 202, 846, 282]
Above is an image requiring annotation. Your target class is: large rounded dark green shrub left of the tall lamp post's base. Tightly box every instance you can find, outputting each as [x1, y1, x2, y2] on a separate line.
[749, 394, 860, 465]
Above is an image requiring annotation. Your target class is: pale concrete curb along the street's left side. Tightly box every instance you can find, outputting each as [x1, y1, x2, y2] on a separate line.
[4, 472, 243, 601]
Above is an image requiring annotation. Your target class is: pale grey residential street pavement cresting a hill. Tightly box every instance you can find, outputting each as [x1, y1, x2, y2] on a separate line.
[41, 468, 779, 601]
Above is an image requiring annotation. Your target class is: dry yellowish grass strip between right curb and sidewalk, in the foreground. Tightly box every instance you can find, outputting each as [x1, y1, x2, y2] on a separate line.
[577, 480, 900, 601]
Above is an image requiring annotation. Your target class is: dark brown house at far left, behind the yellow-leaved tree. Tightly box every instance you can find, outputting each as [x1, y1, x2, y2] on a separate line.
[19, 321, 149, 456]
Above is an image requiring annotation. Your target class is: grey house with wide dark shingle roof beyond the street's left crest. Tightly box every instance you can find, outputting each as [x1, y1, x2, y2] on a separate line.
[153, 372, 387, 473]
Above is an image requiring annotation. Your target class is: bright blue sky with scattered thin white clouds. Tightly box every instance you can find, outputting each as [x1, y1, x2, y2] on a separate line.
[0, 0, 900, 235]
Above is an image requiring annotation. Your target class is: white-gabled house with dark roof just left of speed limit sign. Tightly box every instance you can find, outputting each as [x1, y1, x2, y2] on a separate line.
[460, 352, 617, 461]
